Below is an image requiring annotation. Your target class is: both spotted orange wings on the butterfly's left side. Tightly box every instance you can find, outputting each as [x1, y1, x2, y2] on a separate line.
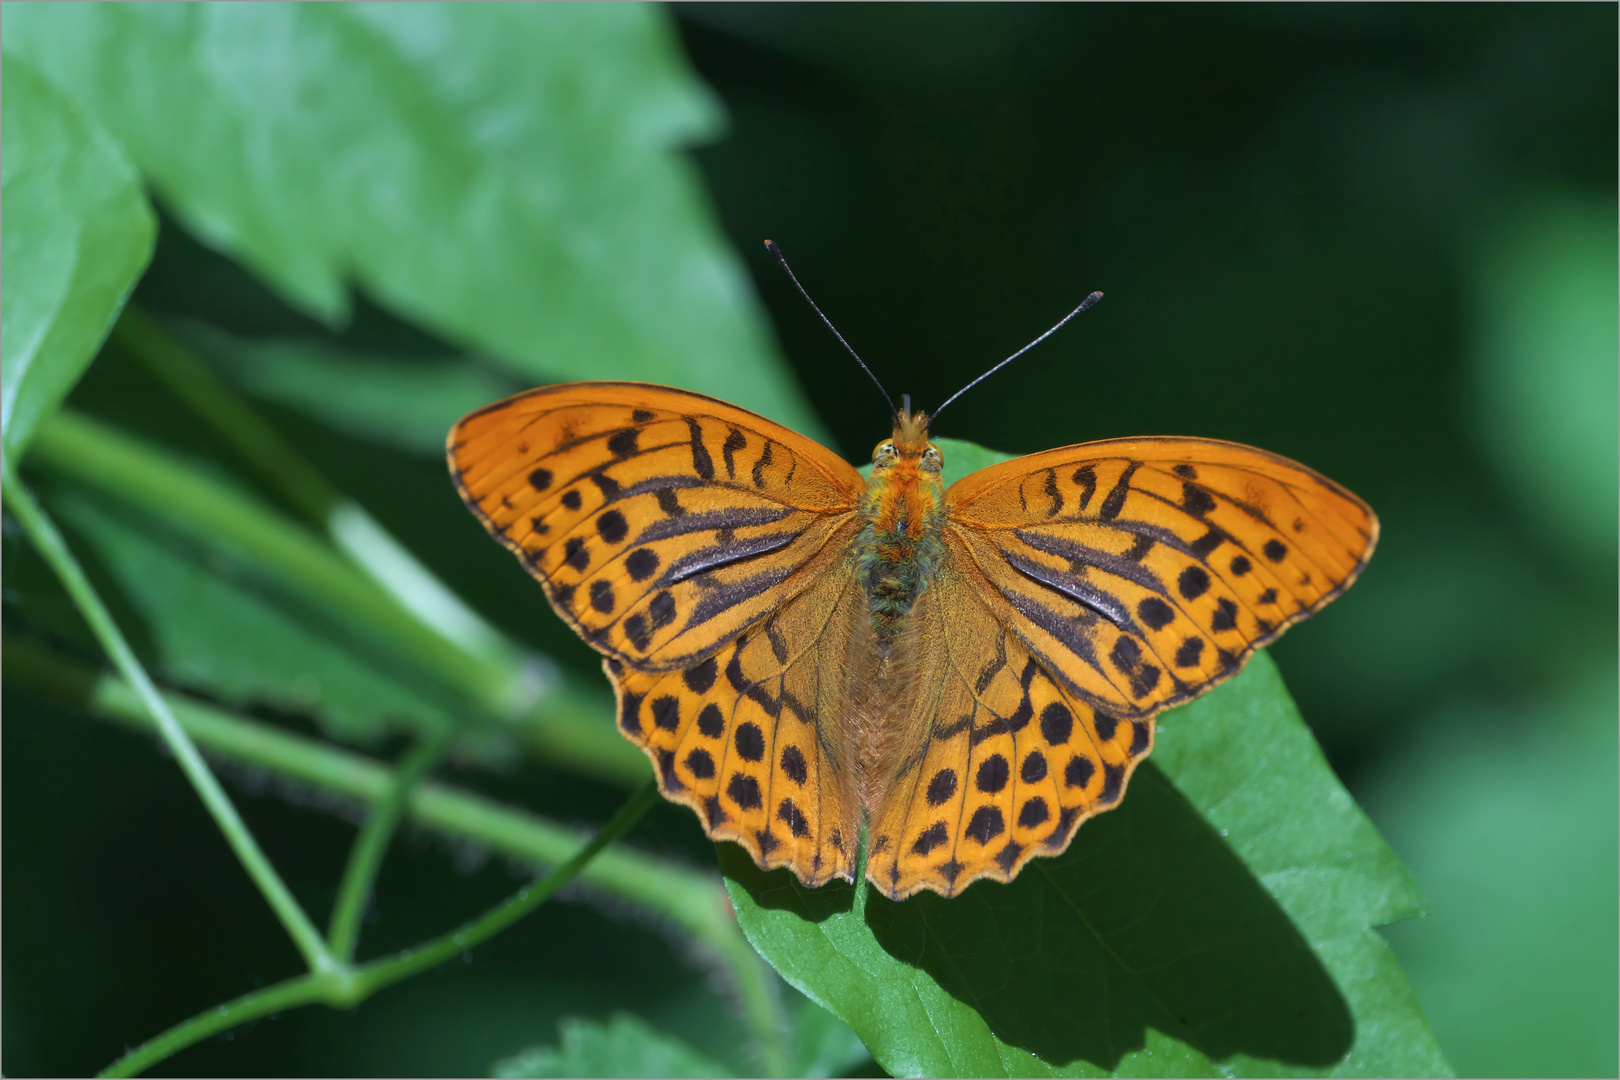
[449, 382, 863, 884]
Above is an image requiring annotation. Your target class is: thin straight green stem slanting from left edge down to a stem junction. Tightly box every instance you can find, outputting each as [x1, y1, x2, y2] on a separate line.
[0, 461, 335, 973]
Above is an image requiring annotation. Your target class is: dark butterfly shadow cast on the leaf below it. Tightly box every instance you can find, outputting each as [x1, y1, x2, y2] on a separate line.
[865, 763, 1354, 1070]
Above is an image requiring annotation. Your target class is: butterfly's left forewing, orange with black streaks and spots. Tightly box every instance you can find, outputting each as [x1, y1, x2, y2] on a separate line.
[447, 382, 862, 672]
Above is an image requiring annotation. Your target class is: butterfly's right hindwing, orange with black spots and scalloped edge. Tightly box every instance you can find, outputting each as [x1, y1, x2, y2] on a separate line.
[867, 539, 1153, 899]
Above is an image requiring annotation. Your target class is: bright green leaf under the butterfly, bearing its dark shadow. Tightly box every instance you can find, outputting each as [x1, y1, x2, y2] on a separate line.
[721, 654, 1447, 1077]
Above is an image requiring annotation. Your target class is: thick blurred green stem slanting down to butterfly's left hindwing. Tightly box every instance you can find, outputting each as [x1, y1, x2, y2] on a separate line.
[29, 410, 648, 785]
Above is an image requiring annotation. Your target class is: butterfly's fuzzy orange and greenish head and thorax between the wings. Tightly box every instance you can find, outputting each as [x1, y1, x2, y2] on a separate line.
[855, 413, 944, 641]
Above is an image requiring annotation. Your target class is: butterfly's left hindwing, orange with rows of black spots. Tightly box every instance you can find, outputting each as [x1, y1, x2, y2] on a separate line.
[606, 540, 865, 886]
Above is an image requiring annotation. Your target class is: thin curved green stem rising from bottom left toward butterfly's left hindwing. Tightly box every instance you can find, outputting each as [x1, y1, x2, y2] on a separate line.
[100, 780, 658, 1077]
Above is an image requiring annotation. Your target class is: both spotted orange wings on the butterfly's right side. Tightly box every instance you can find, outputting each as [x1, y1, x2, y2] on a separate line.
[867, 439, 1379, 899]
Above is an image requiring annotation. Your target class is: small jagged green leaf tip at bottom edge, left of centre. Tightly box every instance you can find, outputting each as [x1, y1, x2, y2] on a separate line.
[491, 1012, 731, 1077]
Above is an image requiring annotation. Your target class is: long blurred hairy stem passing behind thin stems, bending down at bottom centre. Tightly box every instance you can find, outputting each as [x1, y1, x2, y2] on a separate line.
[0, 638, 789, 1075]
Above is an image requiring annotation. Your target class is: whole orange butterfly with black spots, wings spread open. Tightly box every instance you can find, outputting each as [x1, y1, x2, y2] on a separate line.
[449, 249, 1379, 900]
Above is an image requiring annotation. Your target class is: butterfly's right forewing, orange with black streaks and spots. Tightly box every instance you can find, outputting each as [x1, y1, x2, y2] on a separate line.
[946, 439, 1379, 719]
